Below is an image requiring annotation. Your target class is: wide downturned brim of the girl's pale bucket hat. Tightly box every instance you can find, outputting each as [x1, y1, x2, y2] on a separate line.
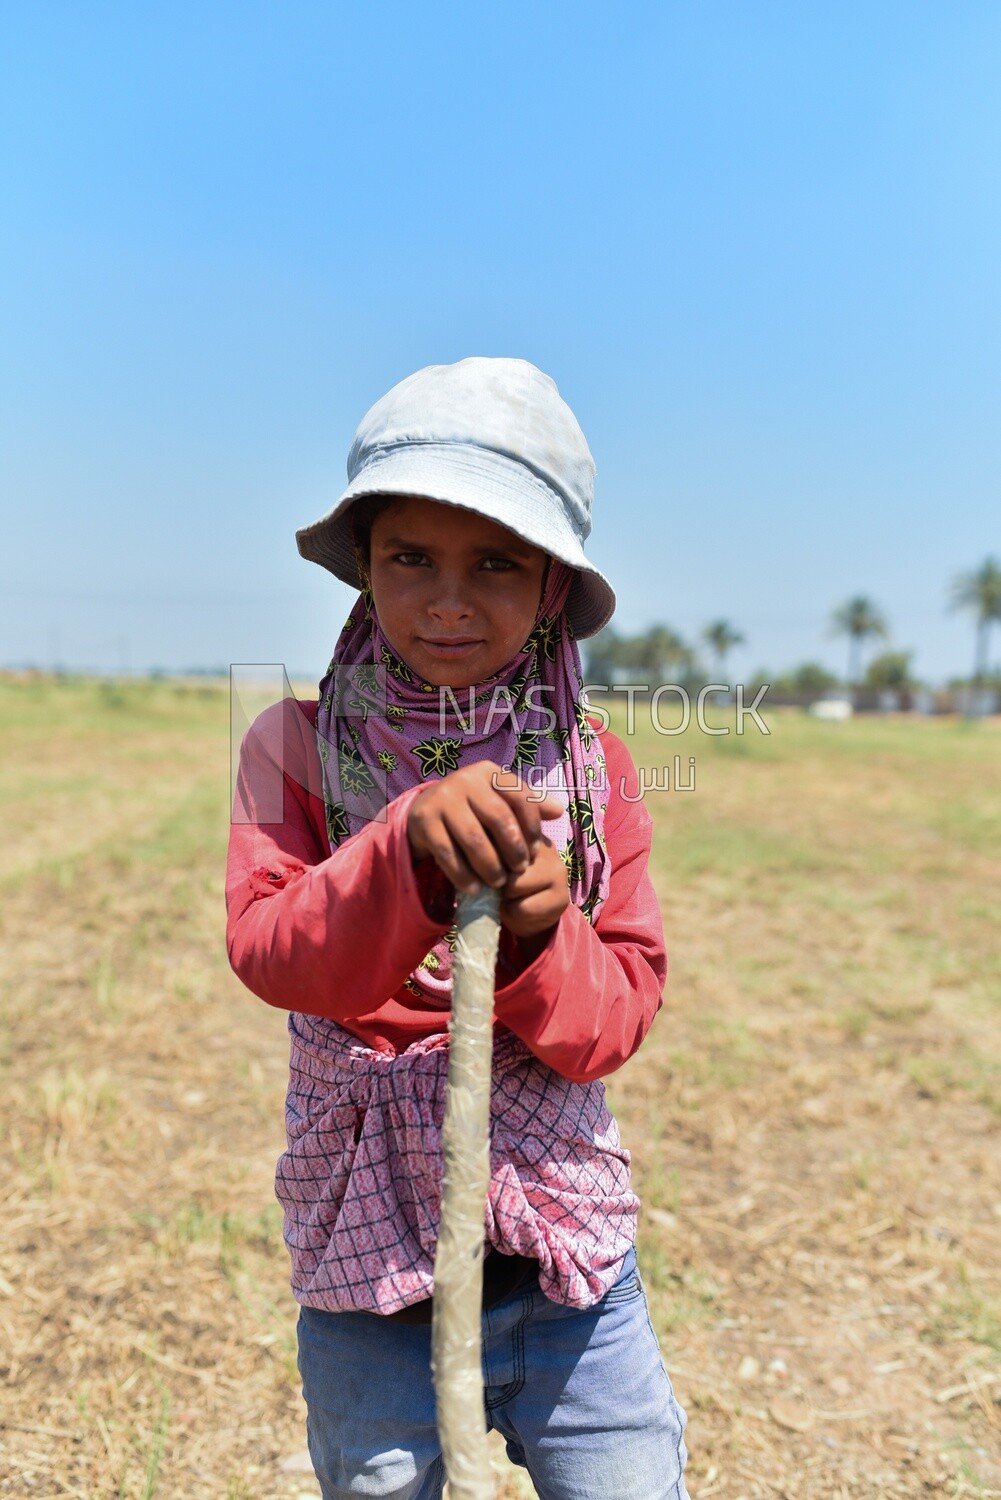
[296, 443, 615, 639]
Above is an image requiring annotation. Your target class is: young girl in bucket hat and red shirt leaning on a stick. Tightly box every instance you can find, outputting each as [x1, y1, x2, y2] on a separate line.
[227, 359, 686, 1500]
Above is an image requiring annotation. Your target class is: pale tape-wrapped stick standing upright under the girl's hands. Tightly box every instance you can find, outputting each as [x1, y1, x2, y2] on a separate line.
[431, 887, 500, 1500]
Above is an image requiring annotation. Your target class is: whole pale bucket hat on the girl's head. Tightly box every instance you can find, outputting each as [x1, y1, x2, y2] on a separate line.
[296, 357, 615, 636]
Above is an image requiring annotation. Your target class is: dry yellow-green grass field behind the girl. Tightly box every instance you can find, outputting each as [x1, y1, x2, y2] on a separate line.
[0, 680, 1001, 1500]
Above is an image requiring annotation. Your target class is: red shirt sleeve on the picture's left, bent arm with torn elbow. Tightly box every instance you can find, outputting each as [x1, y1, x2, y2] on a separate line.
[227, 699, 455, 1020]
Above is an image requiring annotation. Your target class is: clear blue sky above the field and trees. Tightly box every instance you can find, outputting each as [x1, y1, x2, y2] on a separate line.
[0, 0, 1001, 681]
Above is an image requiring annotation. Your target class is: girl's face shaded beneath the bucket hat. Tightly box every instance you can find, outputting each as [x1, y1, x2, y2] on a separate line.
[369, 497, 548, 689]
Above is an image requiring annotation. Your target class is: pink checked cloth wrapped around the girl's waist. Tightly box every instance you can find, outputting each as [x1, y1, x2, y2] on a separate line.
[275, 1013, 639, 1313]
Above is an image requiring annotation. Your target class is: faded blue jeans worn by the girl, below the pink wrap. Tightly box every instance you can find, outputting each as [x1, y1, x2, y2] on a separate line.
[299, 1251, 687, 1500]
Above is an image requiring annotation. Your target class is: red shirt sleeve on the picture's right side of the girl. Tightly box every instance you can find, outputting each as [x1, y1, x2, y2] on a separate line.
[495, 734, 668, 1083]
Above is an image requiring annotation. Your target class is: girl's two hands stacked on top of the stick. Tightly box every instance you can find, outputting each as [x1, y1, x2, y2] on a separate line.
[407, 761, 569, 900]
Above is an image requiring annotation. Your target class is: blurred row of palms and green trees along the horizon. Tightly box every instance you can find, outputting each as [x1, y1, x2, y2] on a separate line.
[587, 557, 1001, 698]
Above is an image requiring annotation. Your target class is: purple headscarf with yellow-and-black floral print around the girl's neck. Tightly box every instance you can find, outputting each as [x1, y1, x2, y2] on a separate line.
[317, 560, 611, 1005]
